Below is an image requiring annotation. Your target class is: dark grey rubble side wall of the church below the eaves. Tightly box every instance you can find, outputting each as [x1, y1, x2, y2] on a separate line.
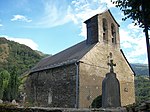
[26, 65, 76, 108]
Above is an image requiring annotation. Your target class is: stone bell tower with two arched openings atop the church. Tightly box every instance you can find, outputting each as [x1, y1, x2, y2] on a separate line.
[84, 10, 120, 49]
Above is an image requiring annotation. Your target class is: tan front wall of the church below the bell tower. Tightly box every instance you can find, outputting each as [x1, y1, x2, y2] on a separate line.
[79, 42, 135, 107]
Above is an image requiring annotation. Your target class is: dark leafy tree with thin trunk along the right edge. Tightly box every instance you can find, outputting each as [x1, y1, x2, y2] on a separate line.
[111, 0, 150, 78]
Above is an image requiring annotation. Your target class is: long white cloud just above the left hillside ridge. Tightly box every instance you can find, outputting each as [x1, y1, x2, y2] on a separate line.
[0, 35, 38, 50]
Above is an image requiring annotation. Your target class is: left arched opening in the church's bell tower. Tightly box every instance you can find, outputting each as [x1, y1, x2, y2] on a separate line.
[103, 18, 108, 42]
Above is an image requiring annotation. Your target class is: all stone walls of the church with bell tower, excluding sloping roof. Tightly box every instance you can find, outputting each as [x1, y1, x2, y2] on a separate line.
[27, 11, 135, 108]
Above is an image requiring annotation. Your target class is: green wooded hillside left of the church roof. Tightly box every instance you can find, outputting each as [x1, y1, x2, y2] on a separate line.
[0, 37, 47, 75]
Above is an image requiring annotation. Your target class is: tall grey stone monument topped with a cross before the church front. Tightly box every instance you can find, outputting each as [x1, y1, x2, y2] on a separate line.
[102, 60, 121, 108]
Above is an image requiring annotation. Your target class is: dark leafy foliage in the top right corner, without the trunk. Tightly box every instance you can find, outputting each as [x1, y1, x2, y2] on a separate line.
[111, 0, 150, 28]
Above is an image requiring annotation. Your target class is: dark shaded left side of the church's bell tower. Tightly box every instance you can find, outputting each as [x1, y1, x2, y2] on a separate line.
[84, 15, 98, 44]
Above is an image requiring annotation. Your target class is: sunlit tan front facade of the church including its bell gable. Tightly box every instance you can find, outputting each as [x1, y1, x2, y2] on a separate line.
[79, 11, 135, 107]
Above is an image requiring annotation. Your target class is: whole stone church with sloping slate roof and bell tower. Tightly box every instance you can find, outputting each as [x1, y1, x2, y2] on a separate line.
[26, 10, 135, 108]
